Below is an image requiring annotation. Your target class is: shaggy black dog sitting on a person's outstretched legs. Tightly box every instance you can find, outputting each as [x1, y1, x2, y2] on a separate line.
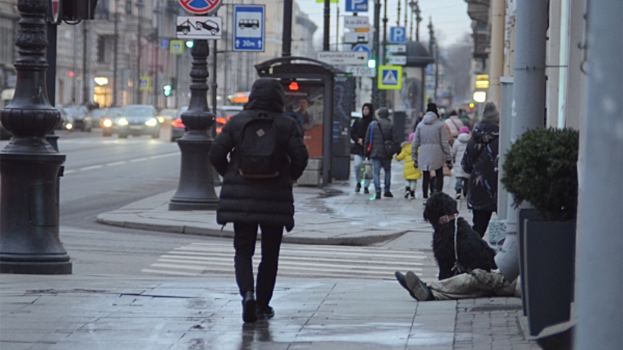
[424, 193, 497, 280]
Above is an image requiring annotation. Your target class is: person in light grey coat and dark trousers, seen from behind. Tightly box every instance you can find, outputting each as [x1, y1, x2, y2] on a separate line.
[411, 112, 452, 203]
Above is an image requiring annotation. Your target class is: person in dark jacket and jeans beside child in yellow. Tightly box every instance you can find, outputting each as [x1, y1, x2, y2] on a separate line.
[364, 107, 400, 200]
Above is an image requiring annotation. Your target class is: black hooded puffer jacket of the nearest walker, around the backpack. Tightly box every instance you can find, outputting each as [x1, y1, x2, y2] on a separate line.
[209, 79, 309, 231]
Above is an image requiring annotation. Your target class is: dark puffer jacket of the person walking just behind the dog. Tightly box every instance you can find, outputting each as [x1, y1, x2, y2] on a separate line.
[461, 121, 500, 211]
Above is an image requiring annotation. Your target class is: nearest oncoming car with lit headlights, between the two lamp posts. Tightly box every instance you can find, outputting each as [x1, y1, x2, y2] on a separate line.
[113, 105, 160, 139]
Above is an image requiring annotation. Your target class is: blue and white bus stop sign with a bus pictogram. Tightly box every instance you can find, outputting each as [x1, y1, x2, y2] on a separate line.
[234, 5, 265, 51]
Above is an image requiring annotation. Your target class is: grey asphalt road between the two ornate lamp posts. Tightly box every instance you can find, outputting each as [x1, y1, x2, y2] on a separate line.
[0, 129, 228, 275]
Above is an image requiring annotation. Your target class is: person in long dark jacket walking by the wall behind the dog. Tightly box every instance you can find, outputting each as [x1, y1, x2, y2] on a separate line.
[461, 102, 500, 237]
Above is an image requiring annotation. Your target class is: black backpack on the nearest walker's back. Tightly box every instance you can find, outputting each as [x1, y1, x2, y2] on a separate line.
[236, 112, 284, 179]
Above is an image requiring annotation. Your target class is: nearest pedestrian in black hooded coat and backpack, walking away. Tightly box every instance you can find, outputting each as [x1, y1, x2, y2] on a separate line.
[209, 78, 309, 322]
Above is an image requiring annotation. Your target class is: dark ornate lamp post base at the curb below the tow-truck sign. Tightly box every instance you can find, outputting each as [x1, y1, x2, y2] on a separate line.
[169, 40, 218, 210]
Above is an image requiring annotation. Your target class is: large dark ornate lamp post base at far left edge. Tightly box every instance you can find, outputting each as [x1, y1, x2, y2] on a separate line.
[0, 0, 72, 274]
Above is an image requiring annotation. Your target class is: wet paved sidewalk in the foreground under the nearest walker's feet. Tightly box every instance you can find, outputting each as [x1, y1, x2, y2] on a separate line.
[0, 275, 539, 350]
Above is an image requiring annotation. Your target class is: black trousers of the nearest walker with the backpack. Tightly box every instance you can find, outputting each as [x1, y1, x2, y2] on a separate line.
[234, 223, 283, 307]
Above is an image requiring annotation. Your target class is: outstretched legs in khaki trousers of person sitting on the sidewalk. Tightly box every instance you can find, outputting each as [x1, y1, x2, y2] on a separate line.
[405, 269, 521, 301]
